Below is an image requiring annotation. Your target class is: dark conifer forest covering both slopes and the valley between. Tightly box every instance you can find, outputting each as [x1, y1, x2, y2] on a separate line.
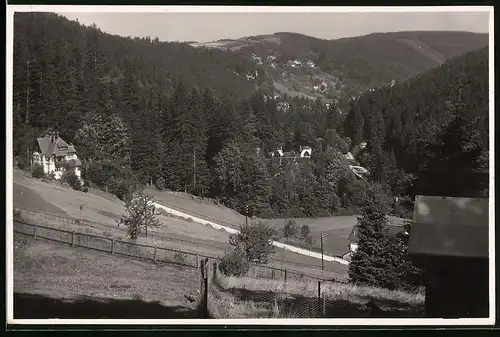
[13, 13, 489, 217]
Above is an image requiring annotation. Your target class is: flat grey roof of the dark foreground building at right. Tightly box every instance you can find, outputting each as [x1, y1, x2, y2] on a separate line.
[408, 195, 489, 258]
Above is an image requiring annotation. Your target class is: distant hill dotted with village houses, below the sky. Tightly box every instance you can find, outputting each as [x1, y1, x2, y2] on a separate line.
[192, 31, 488, 105]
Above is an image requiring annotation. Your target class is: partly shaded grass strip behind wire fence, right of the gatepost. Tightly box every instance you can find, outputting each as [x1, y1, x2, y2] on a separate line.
[211, 274, 425, 318]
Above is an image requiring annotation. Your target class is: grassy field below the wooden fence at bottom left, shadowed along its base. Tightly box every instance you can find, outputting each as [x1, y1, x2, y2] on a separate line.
[14, 234, 200, 318]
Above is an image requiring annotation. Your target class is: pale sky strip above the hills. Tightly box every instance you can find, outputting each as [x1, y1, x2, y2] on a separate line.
[55, 8, 489, 42]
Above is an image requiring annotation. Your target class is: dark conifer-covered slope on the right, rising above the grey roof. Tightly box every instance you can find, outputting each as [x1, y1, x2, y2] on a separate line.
[345, 48, 489, 203]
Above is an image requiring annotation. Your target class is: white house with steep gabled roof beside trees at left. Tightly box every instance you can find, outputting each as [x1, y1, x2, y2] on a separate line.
[31, 133, 82, 181]
